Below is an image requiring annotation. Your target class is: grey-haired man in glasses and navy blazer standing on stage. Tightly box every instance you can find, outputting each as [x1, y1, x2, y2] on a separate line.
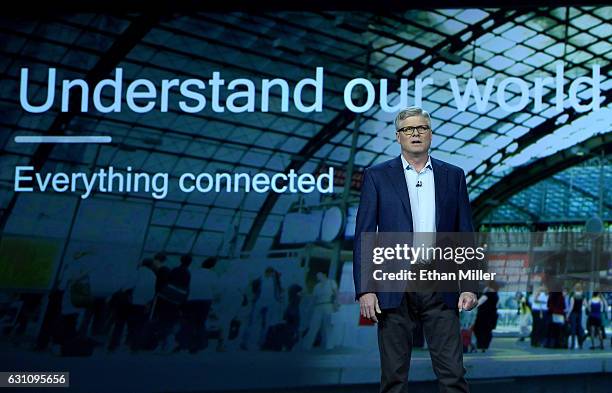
[353, 107, 477, 393]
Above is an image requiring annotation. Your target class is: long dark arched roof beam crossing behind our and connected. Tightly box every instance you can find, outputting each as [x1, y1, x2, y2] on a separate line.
[242, 9, 529, 251]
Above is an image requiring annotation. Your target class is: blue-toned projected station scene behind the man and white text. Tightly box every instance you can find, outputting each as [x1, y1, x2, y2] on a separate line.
[0, 6, 612, 392]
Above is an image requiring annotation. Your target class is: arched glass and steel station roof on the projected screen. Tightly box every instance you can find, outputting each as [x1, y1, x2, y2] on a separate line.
[0, 7, 612, 255]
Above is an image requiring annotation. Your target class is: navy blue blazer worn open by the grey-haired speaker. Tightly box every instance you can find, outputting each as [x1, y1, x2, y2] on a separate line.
[353, 156, 478, 309]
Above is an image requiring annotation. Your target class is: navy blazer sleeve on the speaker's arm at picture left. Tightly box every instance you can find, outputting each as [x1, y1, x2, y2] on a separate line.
[353, 169, 378, 300]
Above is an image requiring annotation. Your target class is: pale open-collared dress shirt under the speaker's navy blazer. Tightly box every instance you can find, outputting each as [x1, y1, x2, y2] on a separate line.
[400, 155, 436, 232]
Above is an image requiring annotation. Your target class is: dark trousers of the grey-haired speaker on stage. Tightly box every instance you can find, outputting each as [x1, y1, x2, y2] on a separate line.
[378, 292, 469, 393]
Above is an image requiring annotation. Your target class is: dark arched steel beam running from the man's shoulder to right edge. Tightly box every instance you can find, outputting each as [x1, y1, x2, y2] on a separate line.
[472, 132, 612, 224]
